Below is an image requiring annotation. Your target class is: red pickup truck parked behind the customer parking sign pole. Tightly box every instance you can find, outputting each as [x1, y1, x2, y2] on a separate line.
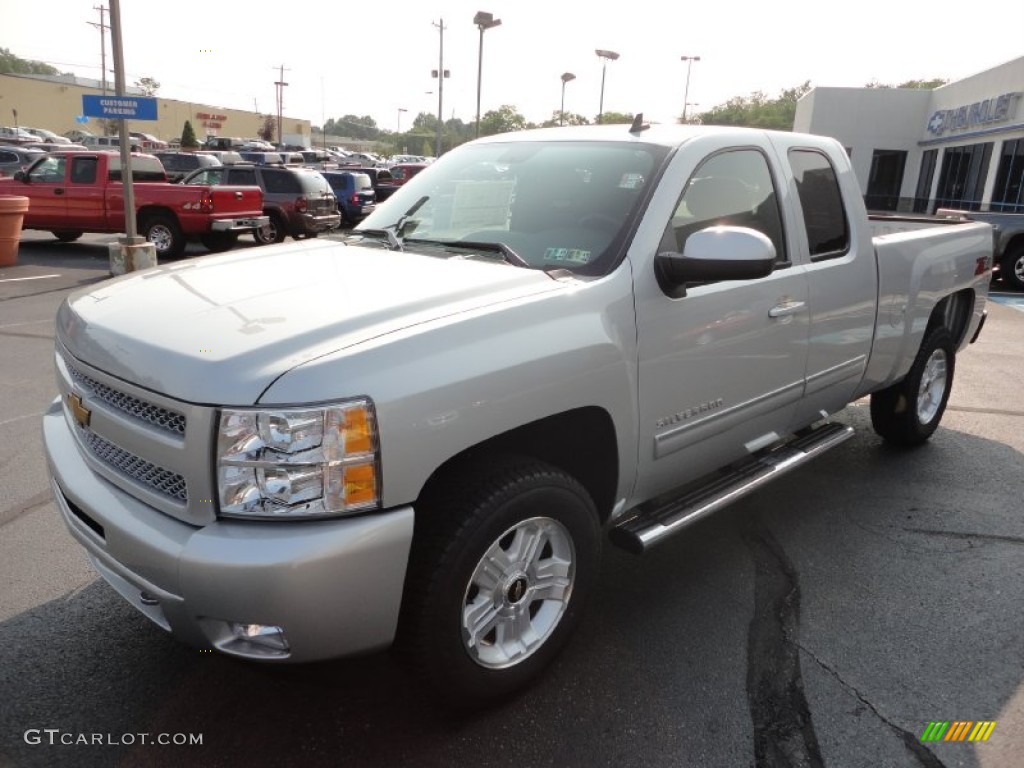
[0, 152, 267, 257]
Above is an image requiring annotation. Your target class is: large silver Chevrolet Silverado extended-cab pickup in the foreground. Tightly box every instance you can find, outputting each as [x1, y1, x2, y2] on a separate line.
[44, 120, 992, 702]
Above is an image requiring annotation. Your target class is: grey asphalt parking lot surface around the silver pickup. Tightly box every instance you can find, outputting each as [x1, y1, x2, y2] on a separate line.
[0, 233, 1024, 768]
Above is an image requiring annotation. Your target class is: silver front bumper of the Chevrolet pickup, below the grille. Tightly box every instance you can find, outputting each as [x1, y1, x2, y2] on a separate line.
[43, 399, 413, 662]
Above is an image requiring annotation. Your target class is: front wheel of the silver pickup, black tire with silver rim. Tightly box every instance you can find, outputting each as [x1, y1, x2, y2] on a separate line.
[396, 457, 601, 709]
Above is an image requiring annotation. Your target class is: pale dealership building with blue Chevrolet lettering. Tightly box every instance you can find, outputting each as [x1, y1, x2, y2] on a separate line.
[793, 56, 1024, 213]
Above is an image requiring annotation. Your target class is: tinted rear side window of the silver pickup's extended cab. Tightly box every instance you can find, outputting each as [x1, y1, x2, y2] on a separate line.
[790, 150, 850, 261]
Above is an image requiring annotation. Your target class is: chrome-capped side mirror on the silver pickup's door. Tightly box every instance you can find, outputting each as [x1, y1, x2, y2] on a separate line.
[654, 226, 775, 286]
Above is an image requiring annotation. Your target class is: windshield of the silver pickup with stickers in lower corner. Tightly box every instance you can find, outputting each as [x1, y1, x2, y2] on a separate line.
[353, 141, 668, 274]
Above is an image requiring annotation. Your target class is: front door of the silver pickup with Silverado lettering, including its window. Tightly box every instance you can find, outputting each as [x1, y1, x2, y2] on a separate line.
[636, 146, 808, 498]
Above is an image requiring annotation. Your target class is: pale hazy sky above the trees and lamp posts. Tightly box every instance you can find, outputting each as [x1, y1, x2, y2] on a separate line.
[0, 0, 1024, 130]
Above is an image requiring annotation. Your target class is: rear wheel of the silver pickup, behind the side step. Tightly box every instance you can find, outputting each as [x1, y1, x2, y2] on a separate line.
[871, 328, 956, 447]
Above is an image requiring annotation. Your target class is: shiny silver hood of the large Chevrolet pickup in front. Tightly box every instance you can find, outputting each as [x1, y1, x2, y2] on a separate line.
[57, 240, 559, 406]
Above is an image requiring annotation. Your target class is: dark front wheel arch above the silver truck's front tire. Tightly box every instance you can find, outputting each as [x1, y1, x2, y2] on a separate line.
[419, 406, 620, 523]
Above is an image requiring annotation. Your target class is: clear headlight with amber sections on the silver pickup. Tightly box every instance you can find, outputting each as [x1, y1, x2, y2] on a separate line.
[217, 400, 380, 520]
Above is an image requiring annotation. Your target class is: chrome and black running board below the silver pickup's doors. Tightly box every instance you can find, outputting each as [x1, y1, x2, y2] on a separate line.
[608, 423, 853, 555]
